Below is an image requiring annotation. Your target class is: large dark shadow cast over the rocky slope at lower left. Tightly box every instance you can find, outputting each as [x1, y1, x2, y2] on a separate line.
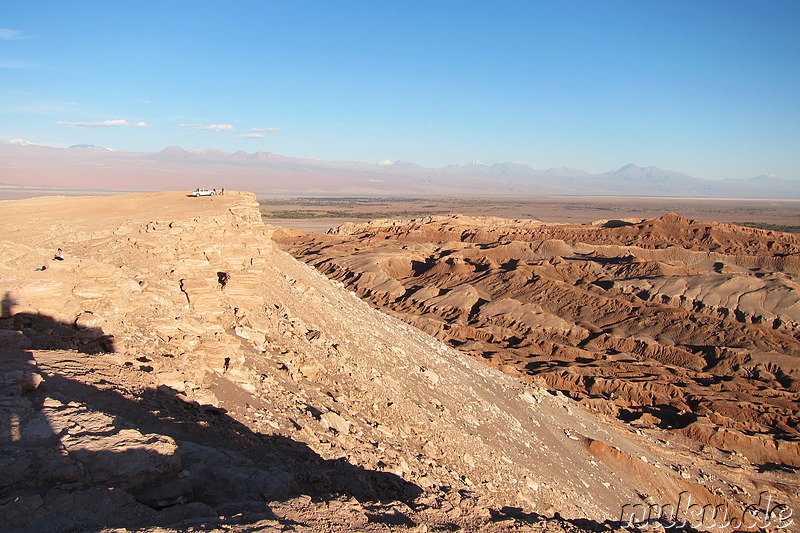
[0, 294, 422, 533]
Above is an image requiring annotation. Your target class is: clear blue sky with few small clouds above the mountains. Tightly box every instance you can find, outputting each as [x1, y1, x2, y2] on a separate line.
[0, 0, 800, 178]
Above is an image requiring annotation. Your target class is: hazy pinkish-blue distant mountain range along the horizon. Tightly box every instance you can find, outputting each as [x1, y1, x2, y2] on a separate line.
[0, 139, 800, 198]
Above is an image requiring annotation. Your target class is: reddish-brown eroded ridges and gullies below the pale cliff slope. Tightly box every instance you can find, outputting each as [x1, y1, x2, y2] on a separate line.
[279, 213, 800, 520]
